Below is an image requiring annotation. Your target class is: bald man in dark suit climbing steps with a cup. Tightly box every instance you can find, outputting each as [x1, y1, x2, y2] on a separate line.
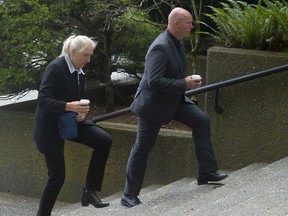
[121, 8, 227, 207]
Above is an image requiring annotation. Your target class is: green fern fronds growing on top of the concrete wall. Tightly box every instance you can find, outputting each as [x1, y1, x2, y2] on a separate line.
[206, 0, 288, 51]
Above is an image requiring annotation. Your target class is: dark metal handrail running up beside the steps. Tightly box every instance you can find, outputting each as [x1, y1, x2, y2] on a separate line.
[92, 64, 288, 122]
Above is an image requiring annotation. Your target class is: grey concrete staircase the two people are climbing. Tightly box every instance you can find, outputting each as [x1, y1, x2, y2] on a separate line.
[0, 157, 288, 216]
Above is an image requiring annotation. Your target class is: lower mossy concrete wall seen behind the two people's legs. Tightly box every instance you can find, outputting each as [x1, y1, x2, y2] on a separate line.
[0, 111, 195, 202]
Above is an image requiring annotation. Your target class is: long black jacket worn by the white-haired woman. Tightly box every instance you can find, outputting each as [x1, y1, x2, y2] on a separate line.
[34, 57, 84, 157]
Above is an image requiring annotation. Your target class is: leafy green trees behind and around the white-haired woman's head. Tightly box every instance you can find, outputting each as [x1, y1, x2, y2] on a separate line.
[0, 0, 164, 94]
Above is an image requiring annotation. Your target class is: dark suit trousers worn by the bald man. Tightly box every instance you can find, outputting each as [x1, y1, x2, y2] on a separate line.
[124, 102, 218, 196]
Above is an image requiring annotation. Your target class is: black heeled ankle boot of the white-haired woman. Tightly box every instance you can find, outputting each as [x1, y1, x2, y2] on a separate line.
[81, 188, 109, 208]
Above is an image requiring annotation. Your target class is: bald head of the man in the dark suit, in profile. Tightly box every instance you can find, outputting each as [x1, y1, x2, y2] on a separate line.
[168, 7, 193, 39]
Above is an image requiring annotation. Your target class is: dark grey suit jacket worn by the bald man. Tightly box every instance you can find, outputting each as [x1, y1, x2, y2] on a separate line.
[130, 30, 193, 124]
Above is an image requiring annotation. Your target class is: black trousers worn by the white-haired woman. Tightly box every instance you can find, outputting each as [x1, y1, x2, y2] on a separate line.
[37, 124, 112, 216]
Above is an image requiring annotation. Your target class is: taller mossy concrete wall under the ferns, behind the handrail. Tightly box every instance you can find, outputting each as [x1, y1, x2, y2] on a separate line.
[203, 47, 288, 169]
